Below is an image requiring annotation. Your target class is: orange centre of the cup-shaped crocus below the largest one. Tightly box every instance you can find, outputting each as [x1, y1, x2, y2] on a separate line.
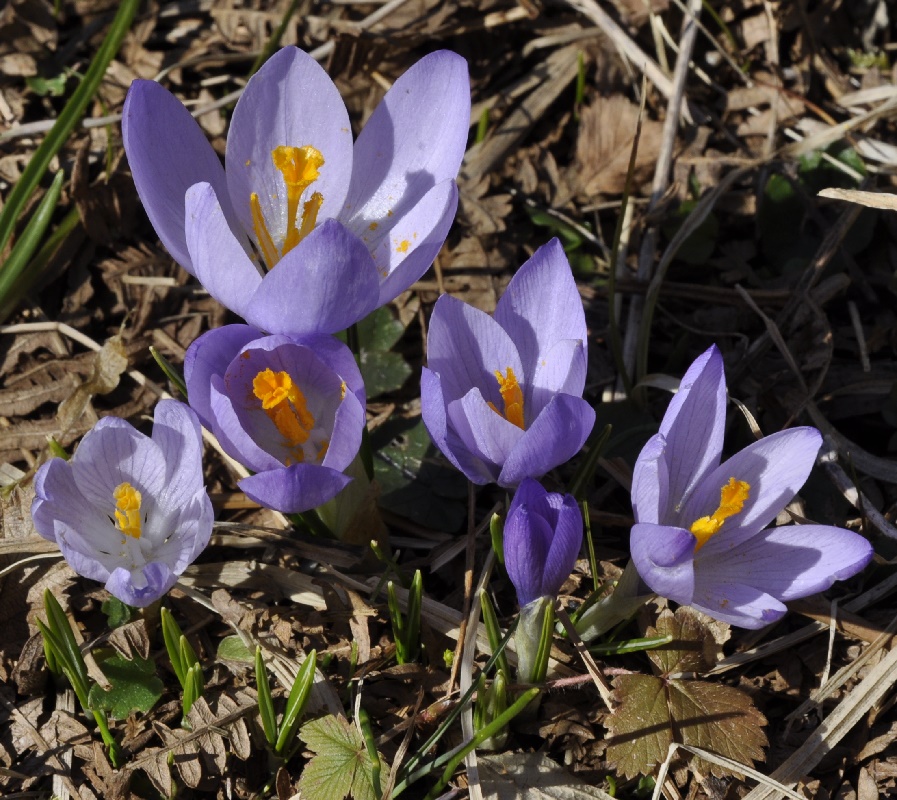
[252, 369, 328, 466]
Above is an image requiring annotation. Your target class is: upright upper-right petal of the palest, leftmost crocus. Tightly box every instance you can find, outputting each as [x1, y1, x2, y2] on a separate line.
[152, 400, 205, 510]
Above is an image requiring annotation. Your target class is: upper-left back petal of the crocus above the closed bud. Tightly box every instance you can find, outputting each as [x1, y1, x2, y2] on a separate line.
[427, 294, 526, 406]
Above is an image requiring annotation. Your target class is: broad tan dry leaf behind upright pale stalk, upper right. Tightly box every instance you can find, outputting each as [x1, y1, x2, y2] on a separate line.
[569, 94, 663, 197]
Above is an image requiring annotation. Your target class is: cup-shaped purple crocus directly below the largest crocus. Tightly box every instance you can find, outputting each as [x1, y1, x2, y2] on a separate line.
[184, 325, 365, 513]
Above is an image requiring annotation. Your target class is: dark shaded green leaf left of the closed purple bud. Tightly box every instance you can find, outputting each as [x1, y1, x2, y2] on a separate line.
[371, 419, 467, 531]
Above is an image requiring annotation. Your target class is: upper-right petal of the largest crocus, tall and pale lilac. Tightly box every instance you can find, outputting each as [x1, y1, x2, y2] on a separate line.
[340, 50, 470, 234]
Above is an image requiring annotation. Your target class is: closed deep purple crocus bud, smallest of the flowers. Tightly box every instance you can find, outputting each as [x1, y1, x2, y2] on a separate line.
[504, 478, 582, 608]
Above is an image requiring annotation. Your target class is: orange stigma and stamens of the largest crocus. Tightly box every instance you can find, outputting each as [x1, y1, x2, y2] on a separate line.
[249, 144, 324, 269]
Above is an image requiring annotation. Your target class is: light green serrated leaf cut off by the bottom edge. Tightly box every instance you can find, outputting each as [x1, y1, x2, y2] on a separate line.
[299, 716, 379, 800]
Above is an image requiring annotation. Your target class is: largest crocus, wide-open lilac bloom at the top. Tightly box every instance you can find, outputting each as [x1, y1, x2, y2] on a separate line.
[122, 47, 470, 336]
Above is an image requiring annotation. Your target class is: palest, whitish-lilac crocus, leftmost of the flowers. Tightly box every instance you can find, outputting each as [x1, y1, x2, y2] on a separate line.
[31, 400, 213, 606]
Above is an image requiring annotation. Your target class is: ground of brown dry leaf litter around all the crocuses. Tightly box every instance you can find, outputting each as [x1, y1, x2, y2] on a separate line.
[0, 0, 897, 800]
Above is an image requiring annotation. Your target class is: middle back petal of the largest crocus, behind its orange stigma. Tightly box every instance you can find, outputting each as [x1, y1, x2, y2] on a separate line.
[225, 47, 352, 243]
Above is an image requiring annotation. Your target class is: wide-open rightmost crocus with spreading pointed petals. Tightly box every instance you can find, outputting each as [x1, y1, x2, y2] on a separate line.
[631, 346, 872, 628]
